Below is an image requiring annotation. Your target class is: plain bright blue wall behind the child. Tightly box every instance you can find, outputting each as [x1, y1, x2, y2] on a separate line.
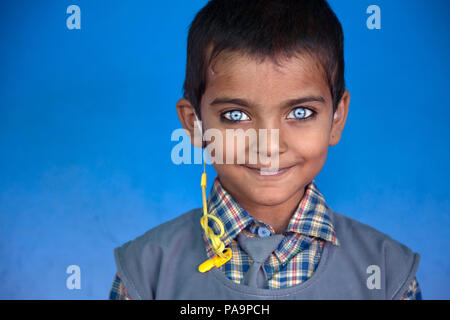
[0, 0, 450, 299]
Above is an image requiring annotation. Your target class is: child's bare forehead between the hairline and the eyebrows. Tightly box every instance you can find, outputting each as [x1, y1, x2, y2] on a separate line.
[204, 53, 331, 104]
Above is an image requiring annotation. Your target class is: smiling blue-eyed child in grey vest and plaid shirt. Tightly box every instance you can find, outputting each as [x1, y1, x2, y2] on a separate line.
[110, 0, 421, 299]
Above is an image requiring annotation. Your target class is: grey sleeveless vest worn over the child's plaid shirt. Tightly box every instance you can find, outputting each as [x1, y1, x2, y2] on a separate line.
[114, 209, 420, 300]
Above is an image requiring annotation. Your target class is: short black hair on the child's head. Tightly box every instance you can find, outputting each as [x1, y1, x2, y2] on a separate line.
[183, 0, 345, 117]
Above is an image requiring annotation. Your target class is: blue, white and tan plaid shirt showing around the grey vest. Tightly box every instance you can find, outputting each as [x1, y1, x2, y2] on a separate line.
[110, 179, 422, 300]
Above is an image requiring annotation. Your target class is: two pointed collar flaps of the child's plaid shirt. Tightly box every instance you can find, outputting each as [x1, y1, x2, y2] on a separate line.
[208, 177, 339, 246]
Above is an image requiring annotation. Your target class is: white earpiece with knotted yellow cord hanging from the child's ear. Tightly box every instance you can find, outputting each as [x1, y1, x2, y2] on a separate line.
[195, 115, 231, 273]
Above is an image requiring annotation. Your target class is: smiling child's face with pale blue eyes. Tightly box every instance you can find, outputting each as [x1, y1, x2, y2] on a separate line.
[178, 54, 349, 206]
